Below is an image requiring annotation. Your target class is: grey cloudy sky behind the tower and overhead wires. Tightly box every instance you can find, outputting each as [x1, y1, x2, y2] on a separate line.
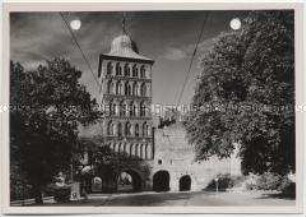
[10, 11, 246, 105]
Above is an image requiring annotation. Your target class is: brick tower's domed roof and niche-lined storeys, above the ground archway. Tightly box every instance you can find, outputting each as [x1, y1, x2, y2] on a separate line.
[98, 31, 154, 160]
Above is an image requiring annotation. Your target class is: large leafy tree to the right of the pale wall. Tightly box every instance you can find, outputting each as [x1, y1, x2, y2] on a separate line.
[185, 11, 295, 174]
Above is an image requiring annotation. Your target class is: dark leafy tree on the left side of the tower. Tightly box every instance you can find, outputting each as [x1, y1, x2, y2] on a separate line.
[10, 58, 98, 203]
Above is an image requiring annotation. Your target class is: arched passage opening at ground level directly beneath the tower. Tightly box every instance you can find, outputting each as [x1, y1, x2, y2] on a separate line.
[117, 171, 141, 192]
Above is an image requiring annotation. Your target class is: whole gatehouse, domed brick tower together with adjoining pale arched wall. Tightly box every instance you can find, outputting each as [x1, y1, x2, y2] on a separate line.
[80, 34, 240, 192]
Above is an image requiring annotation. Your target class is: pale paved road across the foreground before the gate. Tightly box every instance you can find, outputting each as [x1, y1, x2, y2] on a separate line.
[65, 192, 295, 206]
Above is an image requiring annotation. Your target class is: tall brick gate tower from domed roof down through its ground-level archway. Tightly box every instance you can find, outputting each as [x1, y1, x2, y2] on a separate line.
[91, 28, 154, 192]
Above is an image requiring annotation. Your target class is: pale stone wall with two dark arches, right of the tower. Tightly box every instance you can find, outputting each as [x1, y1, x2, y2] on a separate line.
[151, 124, 241, 191]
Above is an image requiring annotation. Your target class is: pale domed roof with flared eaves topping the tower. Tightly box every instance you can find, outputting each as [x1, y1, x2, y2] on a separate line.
[107, 34, 151, 60]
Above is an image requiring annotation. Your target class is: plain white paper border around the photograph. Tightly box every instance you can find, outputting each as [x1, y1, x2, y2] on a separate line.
[0, 2, 306, 214]
